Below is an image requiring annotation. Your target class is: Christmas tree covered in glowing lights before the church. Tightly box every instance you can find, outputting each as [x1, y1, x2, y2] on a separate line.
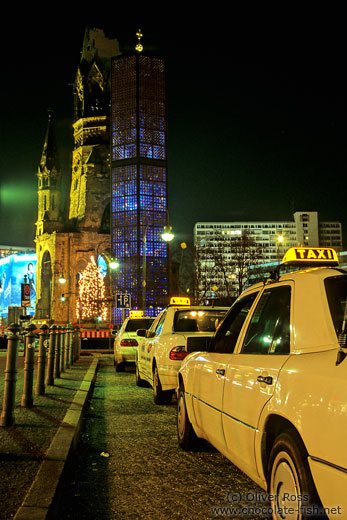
[76, 256, 108, 321]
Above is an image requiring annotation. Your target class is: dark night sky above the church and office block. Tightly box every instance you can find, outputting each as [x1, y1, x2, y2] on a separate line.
[0, 17, 347, 248]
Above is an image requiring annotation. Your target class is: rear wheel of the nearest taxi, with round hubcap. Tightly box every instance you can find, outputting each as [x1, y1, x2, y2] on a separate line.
[268, 432, 326, 520]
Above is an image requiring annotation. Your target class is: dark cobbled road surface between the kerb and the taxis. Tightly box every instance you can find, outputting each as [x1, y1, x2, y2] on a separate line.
[54, 357, 268, 520]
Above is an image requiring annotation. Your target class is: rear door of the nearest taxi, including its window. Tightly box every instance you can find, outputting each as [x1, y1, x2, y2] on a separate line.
[222, 284, 293, 475]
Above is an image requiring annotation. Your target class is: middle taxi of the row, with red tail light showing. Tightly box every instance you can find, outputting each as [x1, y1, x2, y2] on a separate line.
[135, 297, 228, 404]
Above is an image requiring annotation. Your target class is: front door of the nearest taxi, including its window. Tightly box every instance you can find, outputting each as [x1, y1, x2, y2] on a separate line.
[190, 292, 257, 456]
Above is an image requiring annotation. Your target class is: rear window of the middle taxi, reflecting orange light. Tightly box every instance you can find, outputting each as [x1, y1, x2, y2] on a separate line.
[174, 309, 227, 332]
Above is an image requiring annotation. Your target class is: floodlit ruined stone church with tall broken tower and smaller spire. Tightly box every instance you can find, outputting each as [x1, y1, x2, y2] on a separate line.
[35, 28, 119, 324]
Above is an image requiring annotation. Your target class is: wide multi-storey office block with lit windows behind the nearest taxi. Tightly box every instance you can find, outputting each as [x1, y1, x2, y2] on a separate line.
[194, 211, 342, 299]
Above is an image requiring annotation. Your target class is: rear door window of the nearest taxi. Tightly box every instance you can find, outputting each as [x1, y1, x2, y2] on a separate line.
[241, 285, 291, 354]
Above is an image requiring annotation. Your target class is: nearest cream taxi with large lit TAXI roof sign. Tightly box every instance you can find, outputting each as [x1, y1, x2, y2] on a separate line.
[177, 247, 347, 520]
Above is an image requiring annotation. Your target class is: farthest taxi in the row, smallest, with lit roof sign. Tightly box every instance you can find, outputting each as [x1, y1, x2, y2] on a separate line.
[113, 310, 154, 372]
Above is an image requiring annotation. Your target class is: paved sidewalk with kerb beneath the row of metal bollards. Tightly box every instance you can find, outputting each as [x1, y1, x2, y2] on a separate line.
[0, 351, 98, 520]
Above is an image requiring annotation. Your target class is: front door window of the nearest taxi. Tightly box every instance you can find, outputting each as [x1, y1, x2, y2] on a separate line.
[212, 292, 258, 354]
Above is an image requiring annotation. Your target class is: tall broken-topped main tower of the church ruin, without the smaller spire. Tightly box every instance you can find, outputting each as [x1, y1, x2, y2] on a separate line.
[69, 28, 120, 233]
